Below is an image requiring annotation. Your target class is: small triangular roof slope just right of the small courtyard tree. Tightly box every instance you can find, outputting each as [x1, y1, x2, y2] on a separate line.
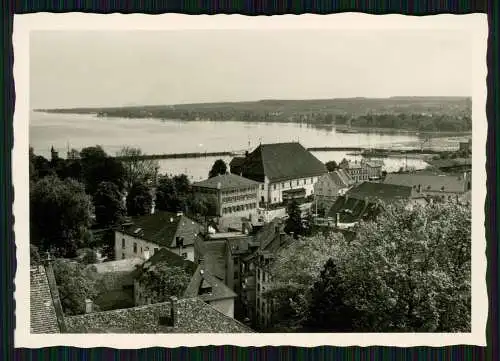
[184, 265, 237, 302]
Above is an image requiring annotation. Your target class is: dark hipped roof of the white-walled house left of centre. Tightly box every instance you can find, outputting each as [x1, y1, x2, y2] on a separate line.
[119, 211, 203, 248]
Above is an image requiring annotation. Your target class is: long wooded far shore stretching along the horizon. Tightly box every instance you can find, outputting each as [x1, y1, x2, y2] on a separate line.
[35, 97, 472, 132]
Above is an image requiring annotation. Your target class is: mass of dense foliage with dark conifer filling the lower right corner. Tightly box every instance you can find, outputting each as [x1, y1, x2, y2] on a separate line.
[268, 202, 471, 332]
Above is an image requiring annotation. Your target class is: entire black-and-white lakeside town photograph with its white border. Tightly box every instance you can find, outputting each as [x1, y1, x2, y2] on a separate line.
[13, 14, 487, 348]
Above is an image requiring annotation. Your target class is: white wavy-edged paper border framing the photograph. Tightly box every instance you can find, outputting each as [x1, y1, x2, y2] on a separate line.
[12, 13, 488, 349]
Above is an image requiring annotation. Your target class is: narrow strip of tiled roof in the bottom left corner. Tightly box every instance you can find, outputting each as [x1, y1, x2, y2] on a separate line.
[30, 266, 60, 333]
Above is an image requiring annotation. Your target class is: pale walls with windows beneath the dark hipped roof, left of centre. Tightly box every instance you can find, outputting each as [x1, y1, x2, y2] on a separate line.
[115, 231, 194, 262]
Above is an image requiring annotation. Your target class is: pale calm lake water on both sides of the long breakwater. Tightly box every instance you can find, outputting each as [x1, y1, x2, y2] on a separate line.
[30, 112, 463, 181]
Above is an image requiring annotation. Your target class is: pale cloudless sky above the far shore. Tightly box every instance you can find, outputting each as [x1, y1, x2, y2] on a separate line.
[30, 29, 473, 108]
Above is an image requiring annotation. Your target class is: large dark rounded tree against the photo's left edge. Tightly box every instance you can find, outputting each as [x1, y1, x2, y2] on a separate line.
[30, 176, 92, 256]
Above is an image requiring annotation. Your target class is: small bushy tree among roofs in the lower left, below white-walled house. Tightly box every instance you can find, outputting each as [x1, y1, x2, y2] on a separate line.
[138, 263, 191, 302]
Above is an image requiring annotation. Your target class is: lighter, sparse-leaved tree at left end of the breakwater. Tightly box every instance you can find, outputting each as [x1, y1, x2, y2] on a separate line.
[117, 147, 160, 190]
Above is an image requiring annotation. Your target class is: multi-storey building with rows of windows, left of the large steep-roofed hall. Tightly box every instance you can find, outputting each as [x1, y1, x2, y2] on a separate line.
[193, 174, 259, 218]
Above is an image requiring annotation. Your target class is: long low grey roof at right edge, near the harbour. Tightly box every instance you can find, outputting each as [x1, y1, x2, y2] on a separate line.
[384, 173, 466, 193]
